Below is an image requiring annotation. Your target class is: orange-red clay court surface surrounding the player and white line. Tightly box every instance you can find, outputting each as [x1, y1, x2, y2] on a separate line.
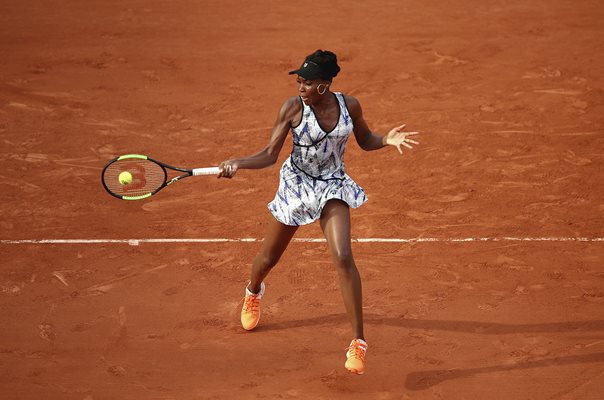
[0, 0, 604, 400]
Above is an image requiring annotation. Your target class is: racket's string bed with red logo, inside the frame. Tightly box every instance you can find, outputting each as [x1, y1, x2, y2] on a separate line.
[103, 159, 167, 197]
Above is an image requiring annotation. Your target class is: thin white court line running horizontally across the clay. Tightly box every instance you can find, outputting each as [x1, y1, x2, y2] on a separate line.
[0, 236, 604, 246]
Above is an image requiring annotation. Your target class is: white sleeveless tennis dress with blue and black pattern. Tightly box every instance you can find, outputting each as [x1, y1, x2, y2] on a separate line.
[268, 93, 367, 226]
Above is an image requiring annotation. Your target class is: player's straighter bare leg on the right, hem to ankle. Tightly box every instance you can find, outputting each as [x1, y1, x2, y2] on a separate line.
[321, 200, 364, 339]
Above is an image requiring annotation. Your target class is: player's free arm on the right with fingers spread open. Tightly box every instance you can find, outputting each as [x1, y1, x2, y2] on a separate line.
[346, 96, 419, 154]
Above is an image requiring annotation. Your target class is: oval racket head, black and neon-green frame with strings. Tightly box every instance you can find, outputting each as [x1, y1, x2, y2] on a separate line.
[101, 154, 168, 200]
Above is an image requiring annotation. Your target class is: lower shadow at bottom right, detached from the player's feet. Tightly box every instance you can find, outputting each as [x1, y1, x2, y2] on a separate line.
[405, 353, 604, 390]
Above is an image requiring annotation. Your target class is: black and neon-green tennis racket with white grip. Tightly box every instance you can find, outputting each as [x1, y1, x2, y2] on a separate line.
[101, 154, 220, 200]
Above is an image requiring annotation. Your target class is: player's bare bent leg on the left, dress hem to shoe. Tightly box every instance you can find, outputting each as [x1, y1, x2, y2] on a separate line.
[248, 216, 298, 293]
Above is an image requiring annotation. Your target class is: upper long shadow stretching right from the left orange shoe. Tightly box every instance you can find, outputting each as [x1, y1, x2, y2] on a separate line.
[258, 313, 604, 335]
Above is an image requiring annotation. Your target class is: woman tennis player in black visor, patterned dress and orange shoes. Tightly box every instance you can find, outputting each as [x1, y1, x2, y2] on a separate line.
[218, 50, 417, 374]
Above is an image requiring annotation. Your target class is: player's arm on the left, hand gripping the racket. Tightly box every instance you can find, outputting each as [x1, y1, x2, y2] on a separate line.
[218, 97, 302, 178]
